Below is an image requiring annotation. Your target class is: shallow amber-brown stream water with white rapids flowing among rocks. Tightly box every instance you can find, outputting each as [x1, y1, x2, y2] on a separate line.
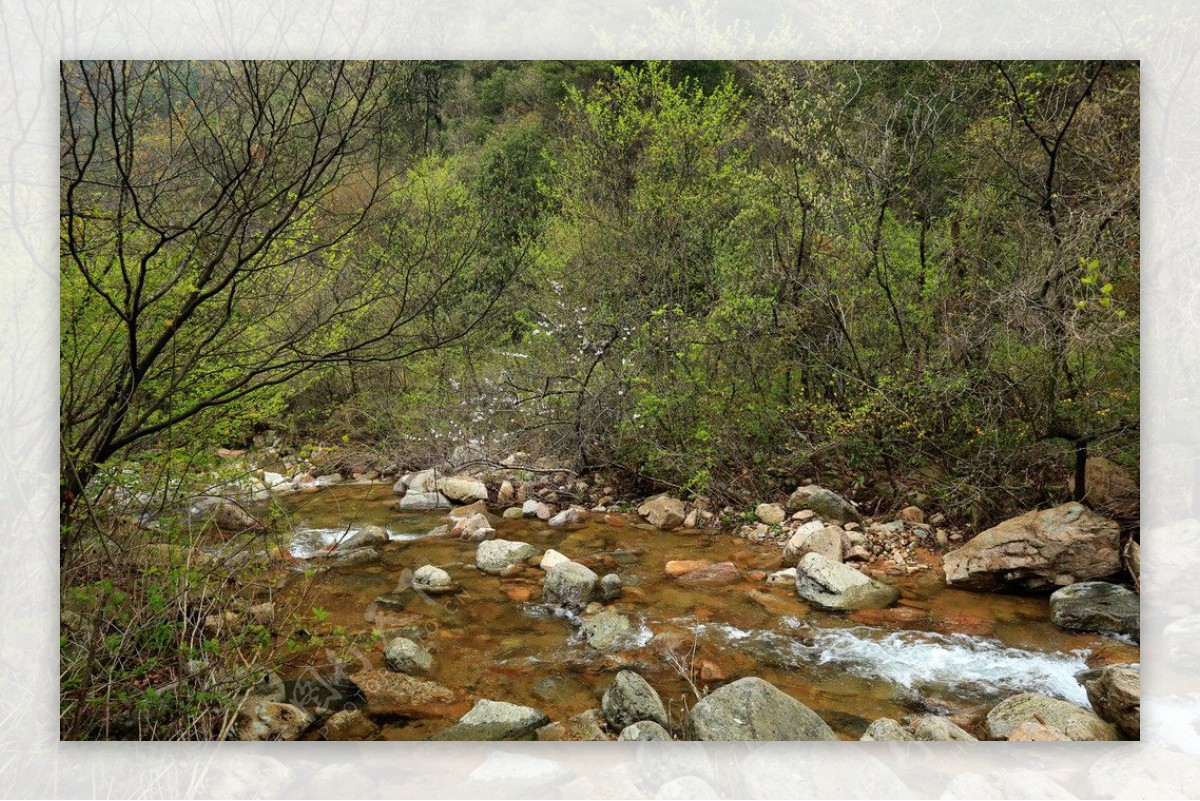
[262, 486, 1138, 740]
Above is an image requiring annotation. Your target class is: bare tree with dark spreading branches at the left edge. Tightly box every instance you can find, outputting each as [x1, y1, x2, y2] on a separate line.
[60, 61, 517, 532]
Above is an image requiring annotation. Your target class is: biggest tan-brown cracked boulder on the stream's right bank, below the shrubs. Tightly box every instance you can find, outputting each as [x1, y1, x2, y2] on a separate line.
[942, 504, 1121, 592]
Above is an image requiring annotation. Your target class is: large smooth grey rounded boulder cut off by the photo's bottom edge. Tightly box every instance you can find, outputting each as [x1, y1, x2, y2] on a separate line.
[684, 676, 838, 740]
